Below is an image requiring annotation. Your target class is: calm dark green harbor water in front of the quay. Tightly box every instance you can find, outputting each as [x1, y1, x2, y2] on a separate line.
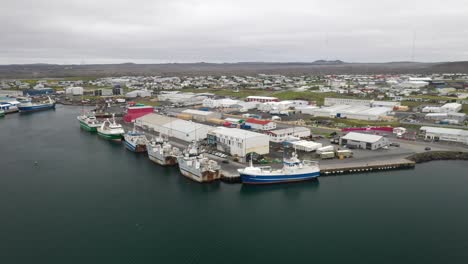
[0, 105, 468, 264]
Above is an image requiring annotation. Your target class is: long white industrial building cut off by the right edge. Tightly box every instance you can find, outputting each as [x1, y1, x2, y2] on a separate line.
[419, 126, 468, 144]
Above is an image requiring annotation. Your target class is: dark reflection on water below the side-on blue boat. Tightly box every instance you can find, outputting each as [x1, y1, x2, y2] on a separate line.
[240, 178, 320, 196]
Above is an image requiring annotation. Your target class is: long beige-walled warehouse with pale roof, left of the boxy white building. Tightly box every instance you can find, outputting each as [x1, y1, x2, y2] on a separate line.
[135, 114, 215, 142]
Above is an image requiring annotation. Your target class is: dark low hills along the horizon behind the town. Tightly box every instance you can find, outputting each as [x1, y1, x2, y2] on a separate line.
[0, 60, 468, 79]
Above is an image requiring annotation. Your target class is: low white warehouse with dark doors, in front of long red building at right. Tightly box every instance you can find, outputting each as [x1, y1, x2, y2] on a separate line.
[340, 132, 389, 150]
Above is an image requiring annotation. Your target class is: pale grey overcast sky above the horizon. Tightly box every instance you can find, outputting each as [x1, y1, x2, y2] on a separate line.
[0, 0, 468, 64]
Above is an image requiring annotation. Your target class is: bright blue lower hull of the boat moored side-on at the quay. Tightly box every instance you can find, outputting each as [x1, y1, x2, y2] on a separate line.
[240, 171, 320, 184]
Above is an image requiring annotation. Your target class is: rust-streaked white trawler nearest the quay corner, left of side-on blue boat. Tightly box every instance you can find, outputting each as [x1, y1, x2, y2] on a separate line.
[177, 142, 221, 182]
